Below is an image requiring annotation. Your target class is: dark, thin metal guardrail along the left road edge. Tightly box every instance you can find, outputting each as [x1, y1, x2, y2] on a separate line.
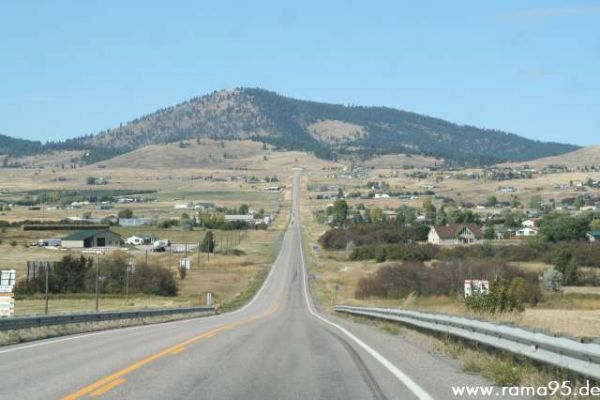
[0, 307, 215, 331]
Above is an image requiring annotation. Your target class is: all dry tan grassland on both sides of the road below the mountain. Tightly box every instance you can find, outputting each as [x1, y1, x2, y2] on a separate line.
[0, 147, 600, 336]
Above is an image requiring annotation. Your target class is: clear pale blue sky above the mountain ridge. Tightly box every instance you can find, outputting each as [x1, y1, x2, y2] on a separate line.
[0, 0, 600, 145]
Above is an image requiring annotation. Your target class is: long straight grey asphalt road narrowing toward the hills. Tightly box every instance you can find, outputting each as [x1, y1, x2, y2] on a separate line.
[0, 173, 502, 400]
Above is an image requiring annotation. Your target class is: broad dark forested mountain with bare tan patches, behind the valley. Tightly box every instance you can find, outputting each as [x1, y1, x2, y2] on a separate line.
[0, 88, 578, 165]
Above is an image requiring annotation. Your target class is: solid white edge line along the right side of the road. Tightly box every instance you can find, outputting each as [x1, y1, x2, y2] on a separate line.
[296, 178, 433, 400]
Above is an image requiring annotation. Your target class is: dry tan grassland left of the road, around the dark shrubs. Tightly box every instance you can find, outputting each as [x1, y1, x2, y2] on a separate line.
[0, 153, 300, 315]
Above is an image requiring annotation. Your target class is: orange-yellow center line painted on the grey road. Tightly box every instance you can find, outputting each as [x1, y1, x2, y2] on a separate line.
[63, 301, 281, 400]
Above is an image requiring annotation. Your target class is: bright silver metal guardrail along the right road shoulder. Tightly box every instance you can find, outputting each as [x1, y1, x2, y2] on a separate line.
[334, 305, 600, 379]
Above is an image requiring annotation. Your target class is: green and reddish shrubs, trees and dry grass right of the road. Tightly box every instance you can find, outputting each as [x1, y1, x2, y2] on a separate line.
[304, 176, 600, 337]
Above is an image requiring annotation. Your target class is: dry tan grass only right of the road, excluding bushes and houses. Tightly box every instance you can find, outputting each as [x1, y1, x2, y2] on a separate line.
[301, 170, 600, 337]
